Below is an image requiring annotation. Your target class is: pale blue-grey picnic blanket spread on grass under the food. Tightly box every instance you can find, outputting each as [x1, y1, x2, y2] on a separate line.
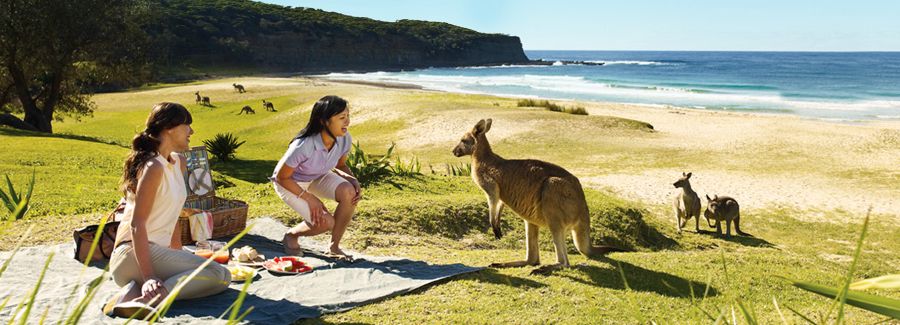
[0, 218, 480, 324]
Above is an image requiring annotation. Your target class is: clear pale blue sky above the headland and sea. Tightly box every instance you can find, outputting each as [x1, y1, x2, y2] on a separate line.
[263, 0, 900, 51]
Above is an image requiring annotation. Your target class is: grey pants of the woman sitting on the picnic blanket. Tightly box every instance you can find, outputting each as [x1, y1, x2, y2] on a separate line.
[109, 243, 231, 300]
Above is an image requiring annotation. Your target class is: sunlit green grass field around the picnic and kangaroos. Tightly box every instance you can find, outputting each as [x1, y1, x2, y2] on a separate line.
[0, 79, 900, 324]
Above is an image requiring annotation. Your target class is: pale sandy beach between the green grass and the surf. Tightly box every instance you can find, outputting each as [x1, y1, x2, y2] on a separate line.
[329, 80, 900, 221]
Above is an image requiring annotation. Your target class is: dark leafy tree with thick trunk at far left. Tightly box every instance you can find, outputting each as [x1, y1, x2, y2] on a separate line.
[0, 0, 149, 133]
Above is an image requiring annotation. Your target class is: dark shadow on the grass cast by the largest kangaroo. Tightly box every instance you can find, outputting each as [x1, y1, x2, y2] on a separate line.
[560, 257, 719, 298]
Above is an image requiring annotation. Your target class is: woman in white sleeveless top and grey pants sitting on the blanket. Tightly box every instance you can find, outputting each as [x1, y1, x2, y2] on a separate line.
[104, 103, 231, 318]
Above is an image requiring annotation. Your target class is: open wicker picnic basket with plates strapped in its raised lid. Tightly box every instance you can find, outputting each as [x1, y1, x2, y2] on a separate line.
[178, 146, 248, 244]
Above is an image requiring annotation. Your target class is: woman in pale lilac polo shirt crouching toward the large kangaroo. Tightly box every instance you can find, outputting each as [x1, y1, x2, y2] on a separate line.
[272, 96, 362, 259]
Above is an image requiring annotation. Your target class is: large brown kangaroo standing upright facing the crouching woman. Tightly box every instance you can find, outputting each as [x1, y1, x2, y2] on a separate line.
[453, 119, 622, 274]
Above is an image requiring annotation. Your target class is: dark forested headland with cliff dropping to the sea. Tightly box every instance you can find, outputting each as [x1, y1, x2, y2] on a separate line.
[144, 0, 528, 72]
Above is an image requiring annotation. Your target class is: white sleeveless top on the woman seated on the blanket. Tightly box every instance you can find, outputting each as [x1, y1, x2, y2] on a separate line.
[116, 153, 187, 247]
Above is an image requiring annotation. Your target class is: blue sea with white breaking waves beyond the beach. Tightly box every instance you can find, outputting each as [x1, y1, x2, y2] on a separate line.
[327, 51, 900, 120]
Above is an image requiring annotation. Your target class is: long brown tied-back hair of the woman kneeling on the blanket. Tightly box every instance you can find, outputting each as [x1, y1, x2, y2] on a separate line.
[120, 102, 193, 196]
